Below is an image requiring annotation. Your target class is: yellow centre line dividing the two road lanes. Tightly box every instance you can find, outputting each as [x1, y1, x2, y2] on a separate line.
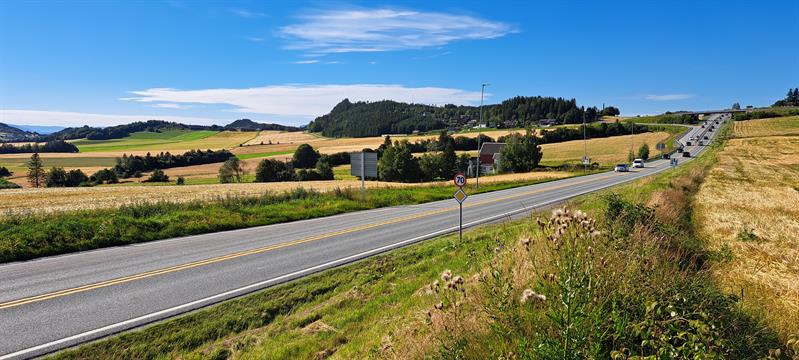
[0, 174, 616, 310]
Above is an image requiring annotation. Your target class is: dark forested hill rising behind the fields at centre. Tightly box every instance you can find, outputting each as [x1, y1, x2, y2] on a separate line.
[308, 96, 618, 137]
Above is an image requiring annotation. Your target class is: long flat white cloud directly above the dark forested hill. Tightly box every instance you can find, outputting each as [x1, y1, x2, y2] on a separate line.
[122, 84, 480, 118]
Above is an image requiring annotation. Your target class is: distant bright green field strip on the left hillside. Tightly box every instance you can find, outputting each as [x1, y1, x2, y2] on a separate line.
[72, 130, 219, 152]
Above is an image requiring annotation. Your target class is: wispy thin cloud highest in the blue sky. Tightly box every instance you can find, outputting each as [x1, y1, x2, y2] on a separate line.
[280, 9, 516, 54]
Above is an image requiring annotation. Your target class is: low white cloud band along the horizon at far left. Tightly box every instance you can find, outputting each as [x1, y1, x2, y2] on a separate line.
[0, 109, 225, 126]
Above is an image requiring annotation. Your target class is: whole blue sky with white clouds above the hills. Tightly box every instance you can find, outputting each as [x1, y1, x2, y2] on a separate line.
[0, 0, 799, 126]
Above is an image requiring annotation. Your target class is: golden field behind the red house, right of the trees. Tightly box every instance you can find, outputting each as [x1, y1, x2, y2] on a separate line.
[541, 132, 671, 165]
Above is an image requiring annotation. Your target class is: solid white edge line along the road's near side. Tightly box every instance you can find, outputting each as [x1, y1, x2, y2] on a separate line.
[0, 155, 688, 360]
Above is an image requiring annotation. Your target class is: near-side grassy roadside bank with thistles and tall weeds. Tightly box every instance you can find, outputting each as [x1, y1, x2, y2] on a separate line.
[50, 123, 790, 359]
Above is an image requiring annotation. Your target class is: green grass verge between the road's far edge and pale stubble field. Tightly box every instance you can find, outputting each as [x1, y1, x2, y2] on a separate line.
[0, 173, 580, 263]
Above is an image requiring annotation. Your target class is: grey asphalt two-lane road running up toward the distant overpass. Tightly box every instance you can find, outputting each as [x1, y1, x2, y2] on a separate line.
[0, 116, 716, 359]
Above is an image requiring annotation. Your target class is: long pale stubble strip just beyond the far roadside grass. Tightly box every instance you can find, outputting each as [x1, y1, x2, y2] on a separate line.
[0, 171, 573, 216]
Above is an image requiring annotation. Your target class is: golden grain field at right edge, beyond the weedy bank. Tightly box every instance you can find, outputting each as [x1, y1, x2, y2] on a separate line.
[695, 117, 799, 339]
